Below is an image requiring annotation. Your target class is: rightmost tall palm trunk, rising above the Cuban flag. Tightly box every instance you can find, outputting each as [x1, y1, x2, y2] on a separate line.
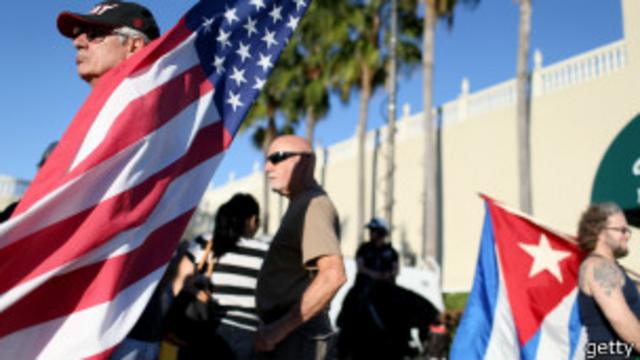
[516, 0, 533, 214]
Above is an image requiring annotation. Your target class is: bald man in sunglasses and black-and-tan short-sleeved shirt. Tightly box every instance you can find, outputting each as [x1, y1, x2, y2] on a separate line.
[254, 135, 346, 359]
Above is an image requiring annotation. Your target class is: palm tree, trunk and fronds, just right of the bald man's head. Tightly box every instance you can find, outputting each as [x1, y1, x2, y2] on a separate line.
[333, 0, 422, 242]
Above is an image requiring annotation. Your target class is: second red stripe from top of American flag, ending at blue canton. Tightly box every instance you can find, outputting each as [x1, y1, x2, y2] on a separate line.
[66, 65, 213, 181]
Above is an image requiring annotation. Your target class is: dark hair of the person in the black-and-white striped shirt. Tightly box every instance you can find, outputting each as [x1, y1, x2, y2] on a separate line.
[213, 193, 260, 256]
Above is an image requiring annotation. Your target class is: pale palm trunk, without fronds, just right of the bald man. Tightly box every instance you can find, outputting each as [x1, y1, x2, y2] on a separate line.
[356, 63, 372, 244]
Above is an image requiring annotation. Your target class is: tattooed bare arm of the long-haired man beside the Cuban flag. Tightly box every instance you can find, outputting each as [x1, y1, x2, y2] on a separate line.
[585, 259, 640, 351]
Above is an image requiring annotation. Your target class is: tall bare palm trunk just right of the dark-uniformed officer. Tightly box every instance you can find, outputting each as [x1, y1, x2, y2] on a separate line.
[422, 0, 441, 263]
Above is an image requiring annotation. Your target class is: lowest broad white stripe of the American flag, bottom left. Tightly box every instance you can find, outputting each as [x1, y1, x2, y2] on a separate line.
[0, 267, 164, 360]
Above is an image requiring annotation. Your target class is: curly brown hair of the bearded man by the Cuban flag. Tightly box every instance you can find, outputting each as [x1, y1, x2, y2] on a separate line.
[578, 203, 622, 252]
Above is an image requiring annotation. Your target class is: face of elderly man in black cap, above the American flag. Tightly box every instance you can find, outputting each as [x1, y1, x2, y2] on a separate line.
[73, 29, 132, 86]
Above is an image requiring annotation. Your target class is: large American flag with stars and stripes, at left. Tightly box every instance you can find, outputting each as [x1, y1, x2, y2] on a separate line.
[0, 0, 309, 359]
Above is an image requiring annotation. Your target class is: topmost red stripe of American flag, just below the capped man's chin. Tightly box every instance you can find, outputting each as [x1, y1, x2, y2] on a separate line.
[13, 19, 192, 216]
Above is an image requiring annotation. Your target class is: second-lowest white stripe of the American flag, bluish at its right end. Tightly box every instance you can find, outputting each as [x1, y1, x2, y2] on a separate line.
[0, 152, 225, 313]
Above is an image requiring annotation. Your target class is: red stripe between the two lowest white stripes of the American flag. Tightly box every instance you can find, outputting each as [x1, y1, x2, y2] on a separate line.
[0, 209, 193, 337]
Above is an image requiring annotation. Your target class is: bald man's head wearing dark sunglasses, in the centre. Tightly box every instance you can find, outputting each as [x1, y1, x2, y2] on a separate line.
[264, 135, 316, 198]
